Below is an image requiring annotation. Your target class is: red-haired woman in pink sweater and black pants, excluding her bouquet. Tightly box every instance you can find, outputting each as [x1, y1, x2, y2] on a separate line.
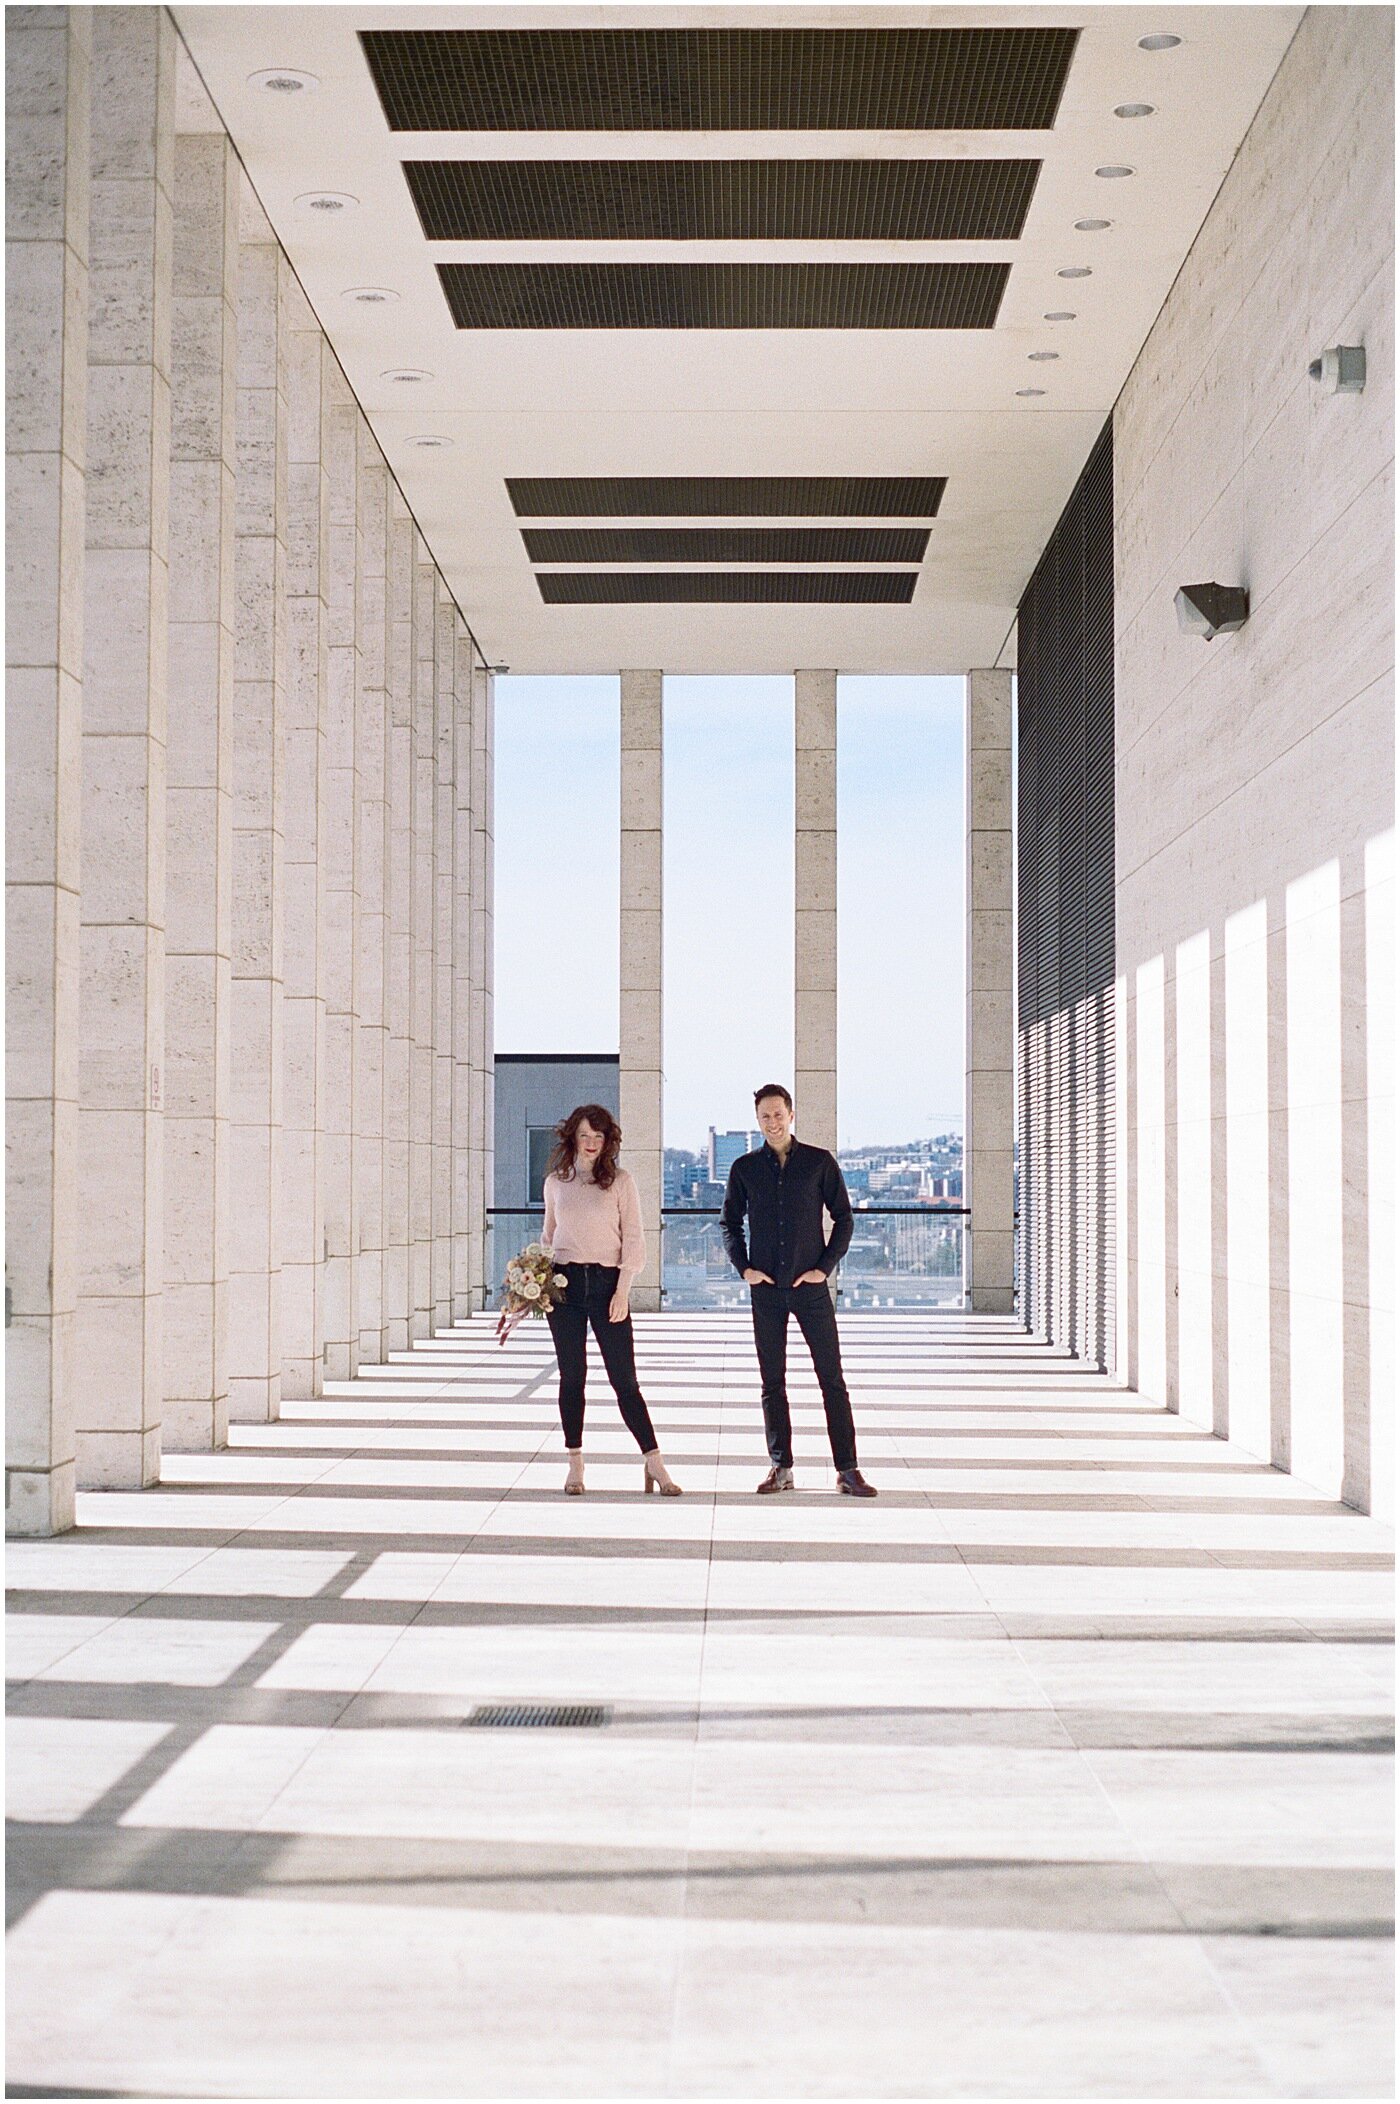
[543, 1102, 680, 1498]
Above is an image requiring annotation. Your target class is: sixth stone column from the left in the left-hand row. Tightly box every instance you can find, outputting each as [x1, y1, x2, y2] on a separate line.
[322, 361, 360, 1380]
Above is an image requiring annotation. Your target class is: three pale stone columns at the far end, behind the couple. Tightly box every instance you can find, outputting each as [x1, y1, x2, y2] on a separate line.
[619, 669, 1015, 1313]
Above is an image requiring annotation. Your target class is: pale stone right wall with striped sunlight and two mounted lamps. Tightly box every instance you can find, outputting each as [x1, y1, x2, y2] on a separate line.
[1114, 6, 1394, 1509]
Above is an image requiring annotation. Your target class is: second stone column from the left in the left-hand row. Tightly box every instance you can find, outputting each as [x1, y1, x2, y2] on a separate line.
[78, 6, 175, 1488]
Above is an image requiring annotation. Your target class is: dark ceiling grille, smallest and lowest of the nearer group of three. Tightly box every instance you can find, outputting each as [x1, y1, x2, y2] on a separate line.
[438, 263, 1011, 328]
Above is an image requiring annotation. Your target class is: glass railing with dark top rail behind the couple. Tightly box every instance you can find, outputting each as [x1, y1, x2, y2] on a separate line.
[486, 1206, 968, 1311]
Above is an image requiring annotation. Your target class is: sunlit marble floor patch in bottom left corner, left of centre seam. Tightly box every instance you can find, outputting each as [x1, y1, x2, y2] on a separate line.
[11, 1894, 680, 2098]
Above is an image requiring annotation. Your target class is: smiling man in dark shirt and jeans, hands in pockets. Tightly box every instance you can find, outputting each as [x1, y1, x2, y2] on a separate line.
[720, 1081, 876, 1498]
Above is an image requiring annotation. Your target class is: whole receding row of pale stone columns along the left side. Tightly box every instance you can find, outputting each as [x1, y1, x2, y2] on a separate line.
[6, 6, 493, 1534]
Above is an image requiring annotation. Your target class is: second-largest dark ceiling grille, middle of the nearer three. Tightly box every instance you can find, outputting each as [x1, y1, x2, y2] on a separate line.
[404, 160, 1040, 242]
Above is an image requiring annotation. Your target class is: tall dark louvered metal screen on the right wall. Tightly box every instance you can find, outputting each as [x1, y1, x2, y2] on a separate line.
[1017, 423, 1116, 1365]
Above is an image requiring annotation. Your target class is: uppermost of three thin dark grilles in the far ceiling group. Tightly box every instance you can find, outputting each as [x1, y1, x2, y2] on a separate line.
[505, 476, 947, 520]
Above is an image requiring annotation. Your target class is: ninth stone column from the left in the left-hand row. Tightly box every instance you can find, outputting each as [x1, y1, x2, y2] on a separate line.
[408, 530, 438, 1342]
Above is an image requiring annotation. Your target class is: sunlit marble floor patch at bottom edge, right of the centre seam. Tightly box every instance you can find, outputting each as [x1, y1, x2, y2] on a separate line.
[672, 1919, 1276, 2098]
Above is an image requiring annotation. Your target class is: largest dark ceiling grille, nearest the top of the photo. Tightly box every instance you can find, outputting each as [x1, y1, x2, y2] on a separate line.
[360, 27, 1078, 133]
